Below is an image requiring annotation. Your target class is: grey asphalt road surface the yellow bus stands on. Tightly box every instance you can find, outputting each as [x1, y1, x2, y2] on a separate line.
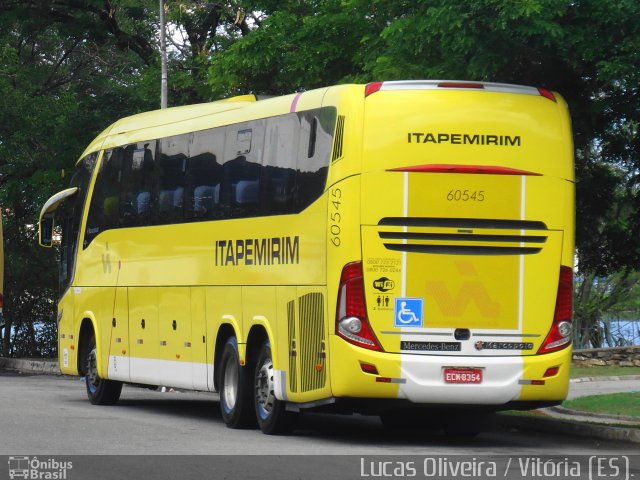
[0, 372, 640, 455]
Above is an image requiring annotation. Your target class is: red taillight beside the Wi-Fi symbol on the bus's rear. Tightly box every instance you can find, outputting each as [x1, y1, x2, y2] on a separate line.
[336, 262, 382, 350]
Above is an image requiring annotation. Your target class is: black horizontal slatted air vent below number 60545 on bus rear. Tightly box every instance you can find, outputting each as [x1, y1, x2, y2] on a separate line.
[378, 217, 547, 255]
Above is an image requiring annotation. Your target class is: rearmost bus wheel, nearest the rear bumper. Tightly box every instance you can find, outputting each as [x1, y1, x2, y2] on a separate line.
[253, 341, 297, 435]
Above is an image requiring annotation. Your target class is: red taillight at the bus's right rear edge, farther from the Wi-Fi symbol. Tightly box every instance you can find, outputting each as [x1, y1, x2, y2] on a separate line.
[538, 266, 573, 353]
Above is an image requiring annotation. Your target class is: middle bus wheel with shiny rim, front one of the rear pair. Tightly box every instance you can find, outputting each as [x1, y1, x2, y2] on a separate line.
[220, 337, 255, 428]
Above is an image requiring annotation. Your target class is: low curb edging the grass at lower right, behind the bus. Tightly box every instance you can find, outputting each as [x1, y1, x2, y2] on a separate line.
[497, 414, 640, 443]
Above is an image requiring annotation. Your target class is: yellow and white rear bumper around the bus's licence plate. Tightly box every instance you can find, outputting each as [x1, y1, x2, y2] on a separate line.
[331, 337, 571, 407]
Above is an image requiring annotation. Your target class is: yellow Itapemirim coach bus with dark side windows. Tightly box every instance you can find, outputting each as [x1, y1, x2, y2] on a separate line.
[40, 81, 574, 433]
